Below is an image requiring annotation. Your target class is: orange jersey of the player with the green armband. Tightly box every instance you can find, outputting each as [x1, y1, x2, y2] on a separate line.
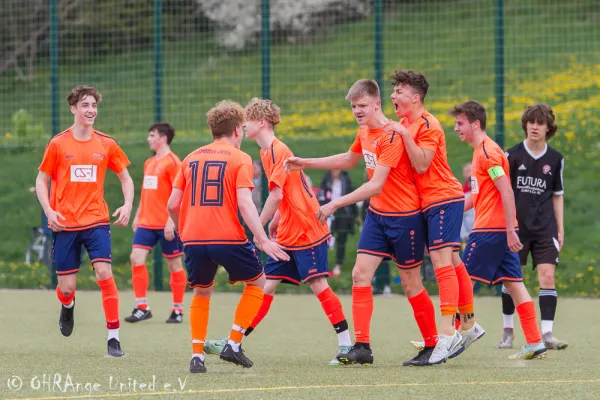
[471, 137, 517, 232]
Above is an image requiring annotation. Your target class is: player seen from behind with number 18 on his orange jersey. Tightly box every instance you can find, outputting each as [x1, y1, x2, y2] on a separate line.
[168, 101, 289, 373]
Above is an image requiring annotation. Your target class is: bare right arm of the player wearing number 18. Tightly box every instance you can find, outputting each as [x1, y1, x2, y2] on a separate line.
[237, 187, 290, 261]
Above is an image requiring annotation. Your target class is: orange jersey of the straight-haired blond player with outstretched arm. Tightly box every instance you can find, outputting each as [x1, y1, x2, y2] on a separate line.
[350, 126, 421, 216]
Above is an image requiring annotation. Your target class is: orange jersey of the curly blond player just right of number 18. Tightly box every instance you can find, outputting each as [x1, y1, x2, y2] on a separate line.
[260, 139, 331, 250]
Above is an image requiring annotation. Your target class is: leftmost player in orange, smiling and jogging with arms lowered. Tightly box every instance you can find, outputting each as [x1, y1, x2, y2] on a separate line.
[35, 86, 134, 357]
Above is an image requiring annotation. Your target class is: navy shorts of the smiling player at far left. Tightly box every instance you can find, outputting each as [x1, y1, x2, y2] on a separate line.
[52, 225, 112, 275]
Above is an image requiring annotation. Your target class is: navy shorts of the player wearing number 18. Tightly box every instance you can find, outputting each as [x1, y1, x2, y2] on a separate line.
[183, 242, 263, 288]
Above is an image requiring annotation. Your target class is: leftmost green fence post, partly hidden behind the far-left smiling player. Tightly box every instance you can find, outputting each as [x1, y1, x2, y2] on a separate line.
[47, 0, 60, 287]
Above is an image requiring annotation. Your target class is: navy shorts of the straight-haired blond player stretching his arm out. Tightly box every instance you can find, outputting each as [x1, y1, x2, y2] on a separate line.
[358, 210, 426, 269]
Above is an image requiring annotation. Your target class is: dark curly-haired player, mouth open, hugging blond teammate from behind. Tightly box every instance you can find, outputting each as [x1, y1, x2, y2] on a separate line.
[385, 70, 485, 364]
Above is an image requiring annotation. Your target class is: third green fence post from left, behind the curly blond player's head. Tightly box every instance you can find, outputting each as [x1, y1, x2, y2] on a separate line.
[260, 0, 271, 263]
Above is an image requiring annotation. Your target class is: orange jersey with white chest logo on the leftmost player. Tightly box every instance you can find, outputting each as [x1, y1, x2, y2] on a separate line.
[39, 129, 129, 231]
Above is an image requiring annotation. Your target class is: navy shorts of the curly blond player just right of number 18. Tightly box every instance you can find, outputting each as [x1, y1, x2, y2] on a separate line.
[265, 242, 329, 285]
